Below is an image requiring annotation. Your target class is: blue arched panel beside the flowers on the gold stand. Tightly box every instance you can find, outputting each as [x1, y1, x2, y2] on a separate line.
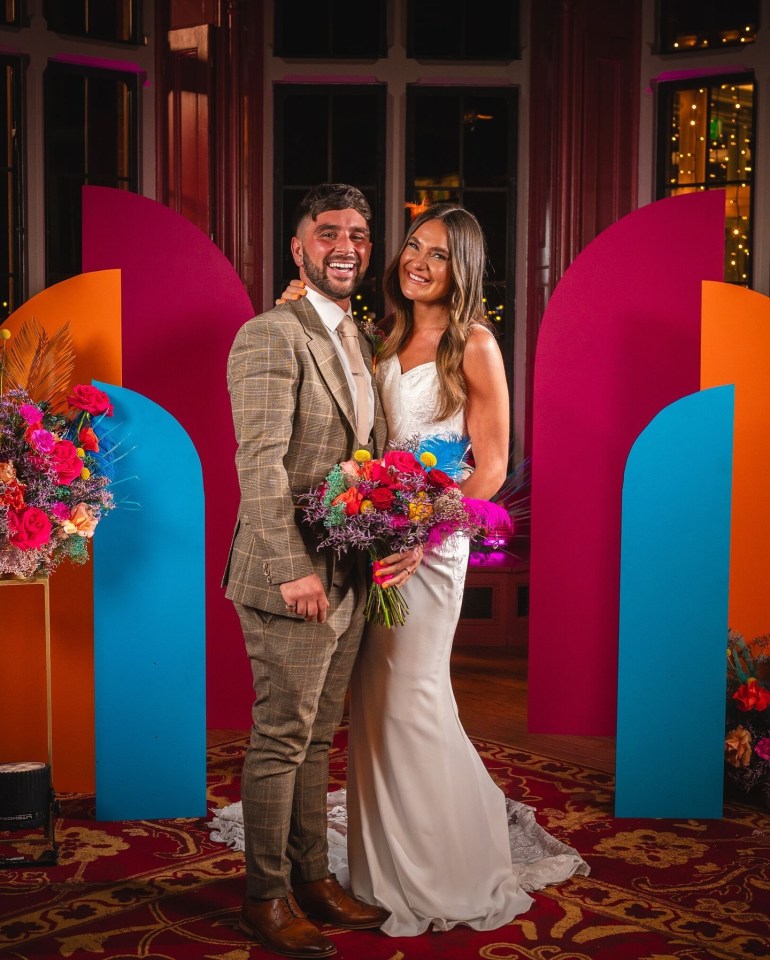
[93, 383, 206, 820]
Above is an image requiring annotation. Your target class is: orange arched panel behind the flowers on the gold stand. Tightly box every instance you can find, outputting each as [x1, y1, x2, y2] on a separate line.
[0, 270, 122, 793]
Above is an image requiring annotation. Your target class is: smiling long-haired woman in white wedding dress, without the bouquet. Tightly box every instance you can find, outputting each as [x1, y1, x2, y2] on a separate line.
[213, 203, 588, 936]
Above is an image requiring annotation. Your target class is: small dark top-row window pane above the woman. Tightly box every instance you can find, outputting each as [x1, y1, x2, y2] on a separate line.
[407, 0, 519, 60]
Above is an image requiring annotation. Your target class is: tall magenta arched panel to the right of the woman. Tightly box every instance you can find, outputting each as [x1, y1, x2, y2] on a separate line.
[528, 190, 724, 736]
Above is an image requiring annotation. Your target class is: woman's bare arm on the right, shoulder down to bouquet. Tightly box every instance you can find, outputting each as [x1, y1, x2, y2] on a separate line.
[462, 327, 510, 500]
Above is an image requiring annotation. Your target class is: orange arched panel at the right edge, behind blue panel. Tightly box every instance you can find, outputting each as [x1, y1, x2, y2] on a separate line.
[701, 282, 770, 641]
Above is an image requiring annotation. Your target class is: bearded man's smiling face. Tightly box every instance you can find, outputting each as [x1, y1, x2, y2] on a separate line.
[291, 209, 372, 306]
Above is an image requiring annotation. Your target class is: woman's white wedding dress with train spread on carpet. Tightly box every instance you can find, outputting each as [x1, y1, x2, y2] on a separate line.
[210, 357, 589, 936]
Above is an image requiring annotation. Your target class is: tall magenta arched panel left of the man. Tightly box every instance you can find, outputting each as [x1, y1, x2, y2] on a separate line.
[83, 187, 255, 728]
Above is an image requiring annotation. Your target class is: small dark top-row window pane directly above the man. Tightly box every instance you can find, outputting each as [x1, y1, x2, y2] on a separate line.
[275, 0, 387, 60]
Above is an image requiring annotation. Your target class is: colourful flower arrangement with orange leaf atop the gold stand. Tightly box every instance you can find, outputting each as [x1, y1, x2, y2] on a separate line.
[0, 320, 114, 578]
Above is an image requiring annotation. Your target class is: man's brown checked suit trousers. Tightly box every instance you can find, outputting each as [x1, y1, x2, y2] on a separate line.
[235, 578, 364, 899]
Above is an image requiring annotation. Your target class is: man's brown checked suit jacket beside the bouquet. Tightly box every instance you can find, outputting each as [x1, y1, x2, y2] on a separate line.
[223, 298, 386, 615]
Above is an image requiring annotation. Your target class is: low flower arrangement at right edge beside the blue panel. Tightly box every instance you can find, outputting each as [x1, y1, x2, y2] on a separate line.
[725, 631, 770, 809]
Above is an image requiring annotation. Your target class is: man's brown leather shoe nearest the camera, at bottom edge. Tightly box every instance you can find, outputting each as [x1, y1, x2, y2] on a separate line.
[239, 894, 337, 957]
